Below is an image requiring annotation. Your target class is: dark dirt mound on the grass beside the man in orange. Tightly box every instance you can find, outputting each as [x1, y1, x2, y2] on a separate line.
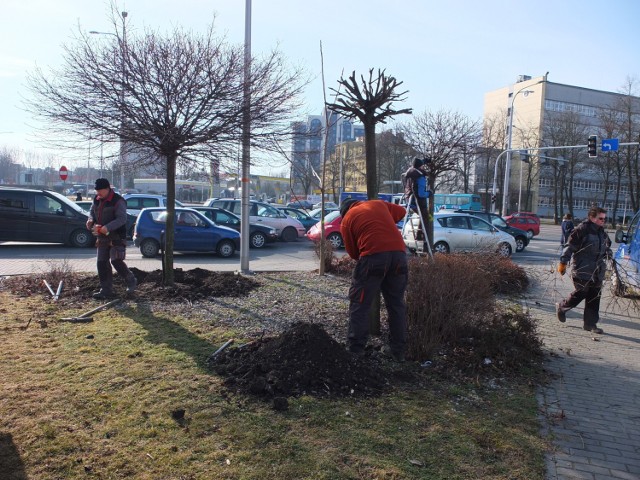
[210, 323, 389, 399]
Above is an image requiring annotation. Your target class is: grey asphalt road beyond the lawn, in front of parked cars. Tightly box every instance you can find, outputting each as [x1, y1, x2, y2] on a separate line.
[0, 225, 617, 276]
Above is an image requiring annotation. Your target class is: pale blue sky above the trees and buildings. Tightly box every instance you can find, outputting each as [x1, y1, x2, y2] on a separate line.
[0, 0, 640, 172]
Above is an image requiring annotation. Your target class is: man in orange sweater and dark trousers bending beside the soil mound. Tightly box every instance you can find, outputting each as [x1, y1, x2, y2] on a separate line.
[340, 198, 408, 361]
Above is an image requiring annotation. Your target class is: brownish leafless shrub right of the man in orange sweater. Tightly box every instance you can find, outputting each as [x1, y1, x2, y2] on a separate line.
[406, 254, 537, 359]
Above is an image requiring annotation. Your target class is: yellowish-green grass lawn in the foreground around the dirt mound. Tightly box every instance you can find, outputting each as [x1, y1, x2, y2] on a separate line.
[0, 274, 547, 480]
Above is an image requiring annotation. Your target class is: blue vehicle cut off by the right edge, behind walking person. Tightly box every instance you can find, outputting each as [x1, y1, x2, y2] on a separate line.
[611, 211, 640, 297]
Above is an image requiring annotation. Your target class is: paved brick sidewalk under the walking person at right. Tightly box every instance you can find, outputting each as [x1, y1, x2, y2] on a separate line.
[526, 267, 640, 480]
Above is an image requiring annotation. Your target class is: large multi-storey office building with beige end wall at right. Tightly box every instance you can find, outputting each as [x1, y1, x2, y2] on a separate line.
[477, 75, 640, 218]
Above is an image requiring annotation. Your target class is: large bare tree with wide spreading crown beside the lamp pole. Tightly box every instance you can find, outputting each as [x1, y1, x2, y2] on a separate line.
[29, 8, 303, 284]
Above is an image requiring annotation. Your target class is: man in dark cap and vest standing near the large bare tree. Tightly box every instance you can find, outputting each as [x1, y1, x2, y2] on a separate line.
[87, 178, 137, 300]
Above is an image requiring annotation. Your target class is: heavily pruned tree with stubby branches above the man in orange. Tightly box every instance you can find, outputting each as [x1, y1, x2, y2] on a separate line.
[326, 68, 412, 199]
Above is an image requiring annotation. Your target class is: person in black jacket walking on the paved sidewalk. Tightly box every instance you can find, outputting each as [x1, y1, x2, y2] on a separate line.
[556, 207, 611, 334]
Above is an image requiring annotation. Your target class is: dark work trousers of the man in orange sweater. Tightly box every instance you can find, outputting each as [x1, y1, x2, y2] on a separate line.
[347, 252, 408, 355]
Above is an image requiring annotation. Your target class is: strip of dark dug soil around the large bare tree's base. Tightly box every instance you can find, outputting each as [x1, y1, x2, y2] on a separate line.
[4, 268, 259, 303]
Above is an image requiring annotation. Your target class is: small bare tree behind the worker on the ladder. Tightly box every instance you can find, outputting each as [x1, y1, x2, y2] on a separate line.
[400, 110, 480, 243]
